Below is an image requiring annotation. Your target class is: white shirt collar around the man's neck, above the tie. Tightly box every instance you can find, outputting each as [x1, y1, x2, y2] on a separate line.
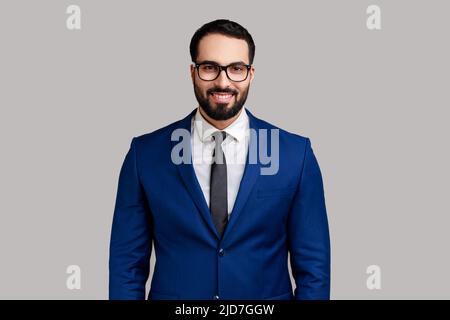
[194, 107, 249, 142]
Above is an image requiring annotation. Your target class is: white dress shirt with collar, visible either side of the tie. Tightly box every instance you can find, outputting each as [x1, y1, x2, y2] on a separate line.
[191, 107, 249, 218]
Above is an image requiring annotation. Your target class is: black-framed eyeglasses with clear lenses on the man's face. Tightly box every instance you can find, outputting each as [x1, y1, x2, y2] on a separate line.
[195, 62, 252, 82]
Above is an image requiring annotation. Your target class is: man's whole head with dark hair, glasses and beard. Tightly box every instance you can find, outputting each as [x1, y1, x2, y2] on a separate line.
[190, 19, 255, 120]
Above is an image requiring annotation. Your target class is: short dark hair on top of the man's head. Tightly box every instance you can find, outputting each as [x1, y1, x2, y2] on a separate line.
[189, 19, 255, 64]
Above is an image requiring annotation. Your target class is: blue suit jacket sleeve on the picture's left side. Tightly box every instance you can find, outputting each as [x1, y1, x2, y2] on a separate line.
[109, 138, 152, 300]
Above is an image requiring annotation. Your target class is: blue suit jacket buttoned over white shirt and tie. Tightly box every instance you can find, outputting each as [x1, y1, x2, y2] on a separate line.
[109, 110, 330, 300]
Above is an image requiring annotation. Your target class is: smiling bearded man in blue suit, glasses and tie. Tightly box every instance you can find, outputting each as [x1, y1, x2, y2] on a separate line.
[109, 20, 330, 300]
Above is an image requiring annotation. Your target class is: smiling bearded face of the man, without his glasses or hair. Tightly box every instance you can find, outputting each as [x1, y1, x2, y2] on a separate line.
[191, 34, 255, 120]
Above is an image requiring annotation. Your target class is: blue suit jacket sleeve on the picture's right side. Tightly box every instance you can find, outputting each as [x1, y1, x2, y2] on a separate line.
[288, 138, 330, 300]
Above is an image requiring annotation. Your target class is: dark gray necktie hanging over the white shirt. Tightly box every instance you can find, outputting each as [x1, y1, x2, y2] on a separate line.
[209, 131, 228, 236]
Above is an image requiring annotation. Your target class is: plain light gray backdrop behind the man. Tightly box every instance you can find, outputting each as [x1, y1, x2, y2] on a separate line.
[0, 0, 450, 299]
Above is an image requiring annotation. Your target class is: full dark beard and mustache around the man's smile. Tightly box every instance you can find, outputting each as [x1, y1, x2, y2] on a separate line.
[194, 79, 250, 120]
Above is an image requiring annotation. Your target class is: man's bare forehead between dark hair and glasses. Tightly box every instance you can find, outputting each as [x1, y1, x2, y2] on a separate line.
[197, 34, 249, 65]
